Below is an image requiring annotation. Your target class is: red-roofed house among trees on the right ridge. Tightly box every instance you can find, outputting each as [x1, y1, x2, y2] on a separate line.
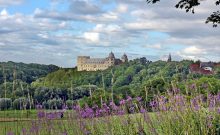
[189, 62, 216, 75]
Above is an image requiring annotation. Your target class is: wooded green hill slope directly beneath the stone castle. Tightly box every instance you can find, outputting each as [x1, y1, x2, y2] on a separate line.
[32, 58, 192, 89]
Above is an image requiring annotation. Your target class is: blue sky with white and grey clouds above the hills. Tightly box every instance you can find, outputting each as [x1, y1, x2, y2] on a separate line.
[0, 0, 220, 67]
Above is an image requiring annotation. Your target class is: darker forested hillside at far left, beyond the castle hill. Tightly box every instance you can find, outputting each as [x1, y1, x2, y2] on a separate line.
[0, 61, 59, 97]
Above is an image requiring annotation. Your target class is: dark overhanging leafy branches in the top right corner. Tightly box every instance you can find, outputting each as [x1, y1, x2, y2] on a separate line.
[147, 0, 220, 27]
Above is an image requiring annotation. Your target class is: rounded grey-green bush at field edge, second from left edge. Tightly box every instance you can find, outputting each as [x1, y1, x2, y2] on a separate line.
[13, 97, 30, 110]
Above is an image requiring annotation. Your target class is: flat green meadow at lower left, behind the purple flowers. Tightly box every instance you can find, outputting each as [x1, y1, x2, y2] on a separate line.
[0, 110, 140, 135]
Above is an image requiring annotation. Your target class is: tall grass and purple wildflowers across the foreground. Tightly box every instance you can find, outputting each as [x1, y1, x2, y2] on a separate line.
[1, 89, 220, 135]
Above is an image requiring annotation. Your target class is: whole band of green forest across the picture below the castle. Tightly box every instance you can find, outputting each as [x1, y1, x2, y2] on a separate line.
[0, 57, 220, 109]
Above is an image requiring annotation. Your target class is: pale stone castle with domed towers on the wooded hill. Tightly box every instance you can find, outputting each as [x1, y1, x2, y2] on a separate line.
[77, 52, 128, 71]
